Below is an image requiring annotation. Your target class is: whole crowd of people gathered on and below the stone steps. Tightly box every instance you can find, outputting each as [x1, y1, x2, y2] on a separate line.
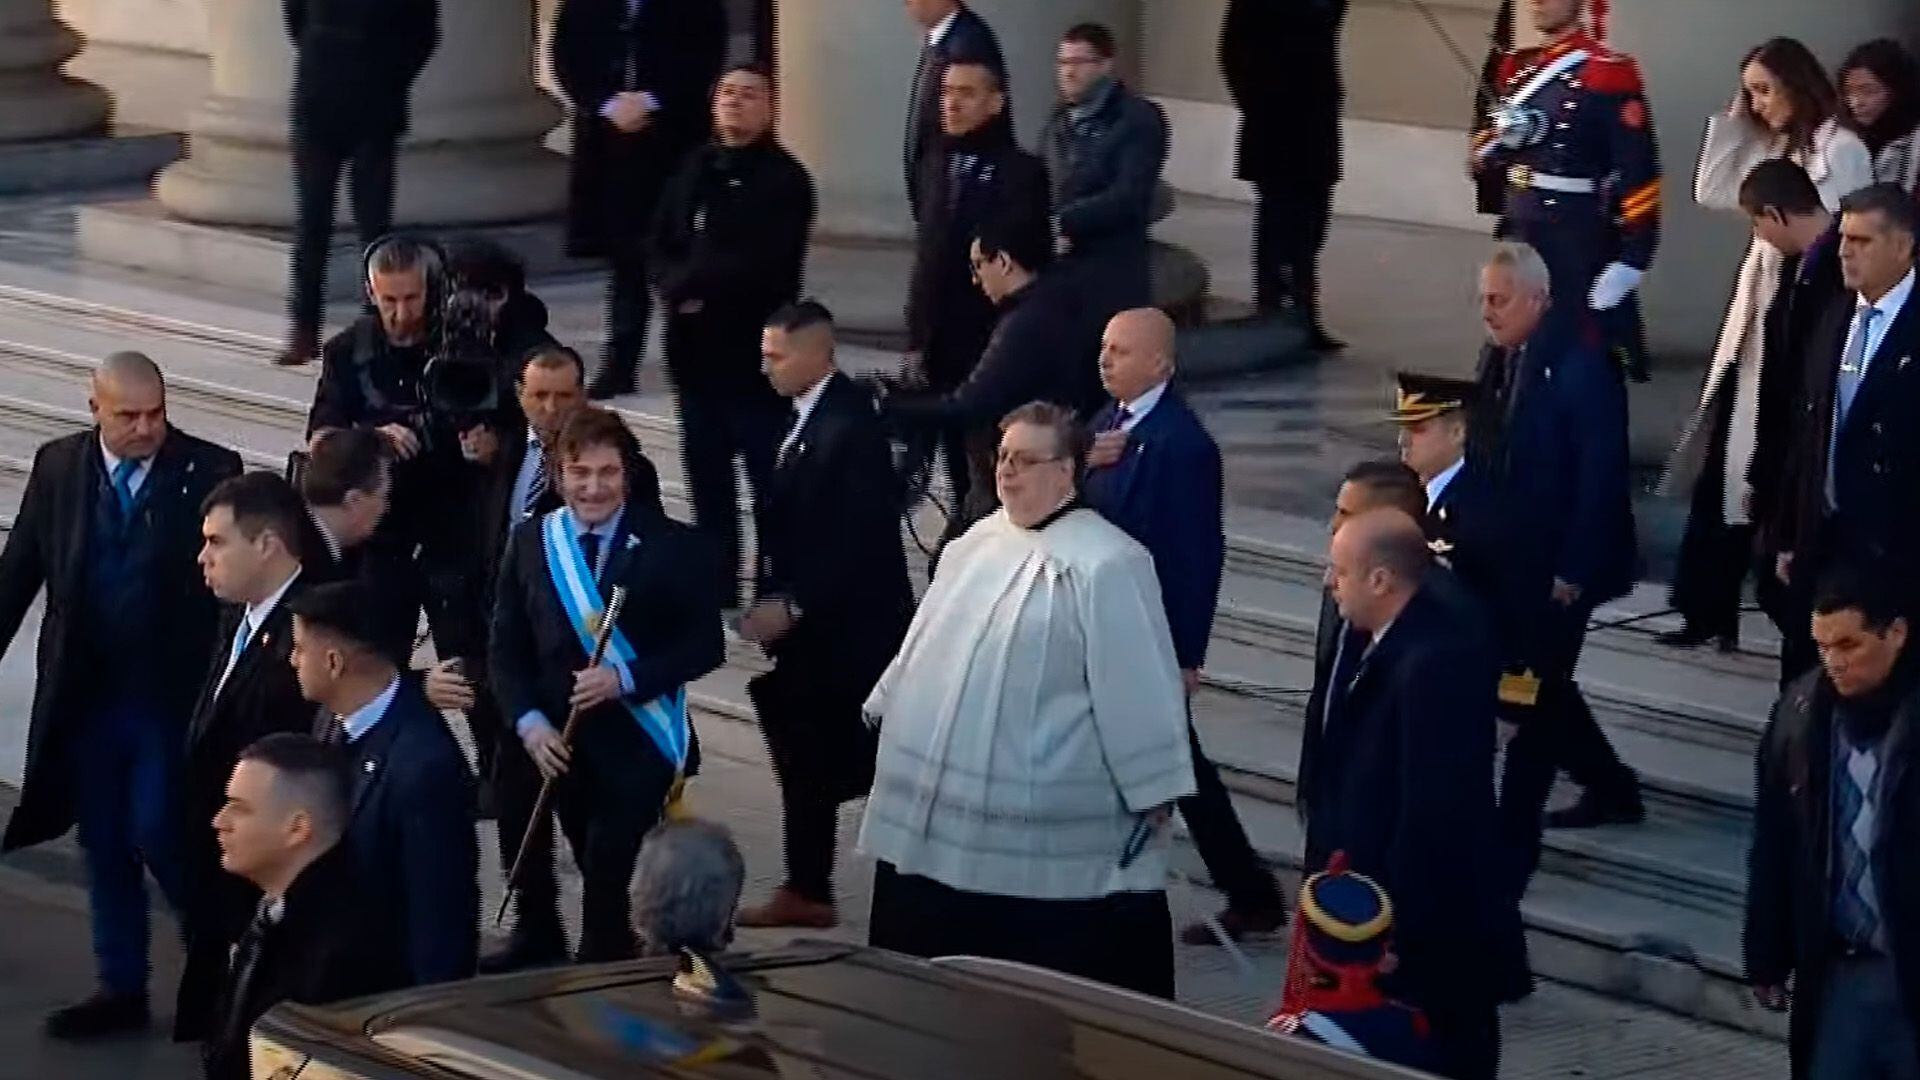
[0, 0, 1920, 1080]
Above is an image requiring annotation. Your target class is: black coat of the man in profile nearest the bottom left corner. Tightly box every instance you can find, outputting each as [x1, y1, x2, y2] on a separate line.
[202, 844, 405, 1080]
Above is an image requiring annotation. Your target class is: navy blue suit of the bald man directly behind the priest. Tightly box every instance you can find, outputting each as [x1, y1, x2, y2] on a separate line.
[1081, 386, 1284, 913]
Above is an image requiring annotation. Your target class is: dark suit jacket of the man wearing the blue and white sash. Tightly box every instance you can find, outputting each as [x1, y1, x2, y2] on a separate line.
[488, 496, 726, 776]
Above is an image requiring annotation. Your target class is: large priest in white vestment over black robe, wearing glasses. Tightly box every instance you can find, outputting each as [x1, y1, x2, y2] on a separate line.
[860, 404, 1194, 997]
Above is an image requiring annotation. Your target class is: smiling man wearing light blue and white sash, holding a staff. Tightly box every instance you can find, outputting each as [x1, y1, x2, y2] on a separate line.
[488, 409, 726, 961]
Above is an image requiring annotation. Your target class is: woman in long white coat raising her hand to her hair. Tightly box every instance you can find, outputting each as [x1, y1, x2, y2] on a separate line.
[1661, 38, 1874, 650]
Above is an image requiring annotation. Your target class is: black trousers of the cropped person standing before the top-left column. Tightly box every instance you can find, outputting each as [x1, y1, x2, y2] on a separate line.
[288, 125, 399, 350]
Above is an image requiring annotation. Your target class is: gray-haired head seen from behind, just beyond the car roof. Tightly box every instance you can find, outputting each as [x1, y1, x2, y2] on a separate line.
[634, 821, 747, 955]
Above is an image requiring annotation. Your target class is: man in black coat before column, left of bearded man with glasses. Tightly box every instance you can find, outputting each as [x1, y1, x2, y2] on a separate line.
[906, 58, 1048, 526]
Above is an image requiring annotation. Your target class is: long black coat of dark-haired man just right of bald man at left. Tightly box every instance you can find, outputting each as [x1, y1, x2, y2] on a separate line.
[175, 573, 317, 1038]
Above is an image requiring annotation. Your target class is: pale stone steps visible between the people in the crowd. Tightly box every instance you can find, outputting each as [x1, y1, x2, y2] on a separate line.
[0, 286, 1784, 1038]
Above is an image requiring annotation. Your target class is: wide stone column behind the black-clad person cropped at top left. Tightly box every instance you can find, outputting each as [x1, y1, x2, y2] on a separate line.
[157, 0, 566, 229]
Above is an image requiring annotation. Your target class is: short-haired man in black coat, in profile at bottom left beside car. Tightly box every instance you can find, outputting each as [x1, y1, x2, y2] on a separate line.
[202, 734, 405, 1080]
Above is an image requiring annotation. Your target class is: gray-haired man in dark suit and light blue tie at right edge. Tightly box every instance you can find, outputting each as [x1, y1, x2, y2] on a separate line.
[1780, 184, 1920, 614]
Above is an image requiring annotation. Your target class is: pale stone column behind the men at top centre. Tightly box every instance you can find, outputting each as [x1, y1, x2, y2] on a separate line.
[774, 0, 1139, 238]
